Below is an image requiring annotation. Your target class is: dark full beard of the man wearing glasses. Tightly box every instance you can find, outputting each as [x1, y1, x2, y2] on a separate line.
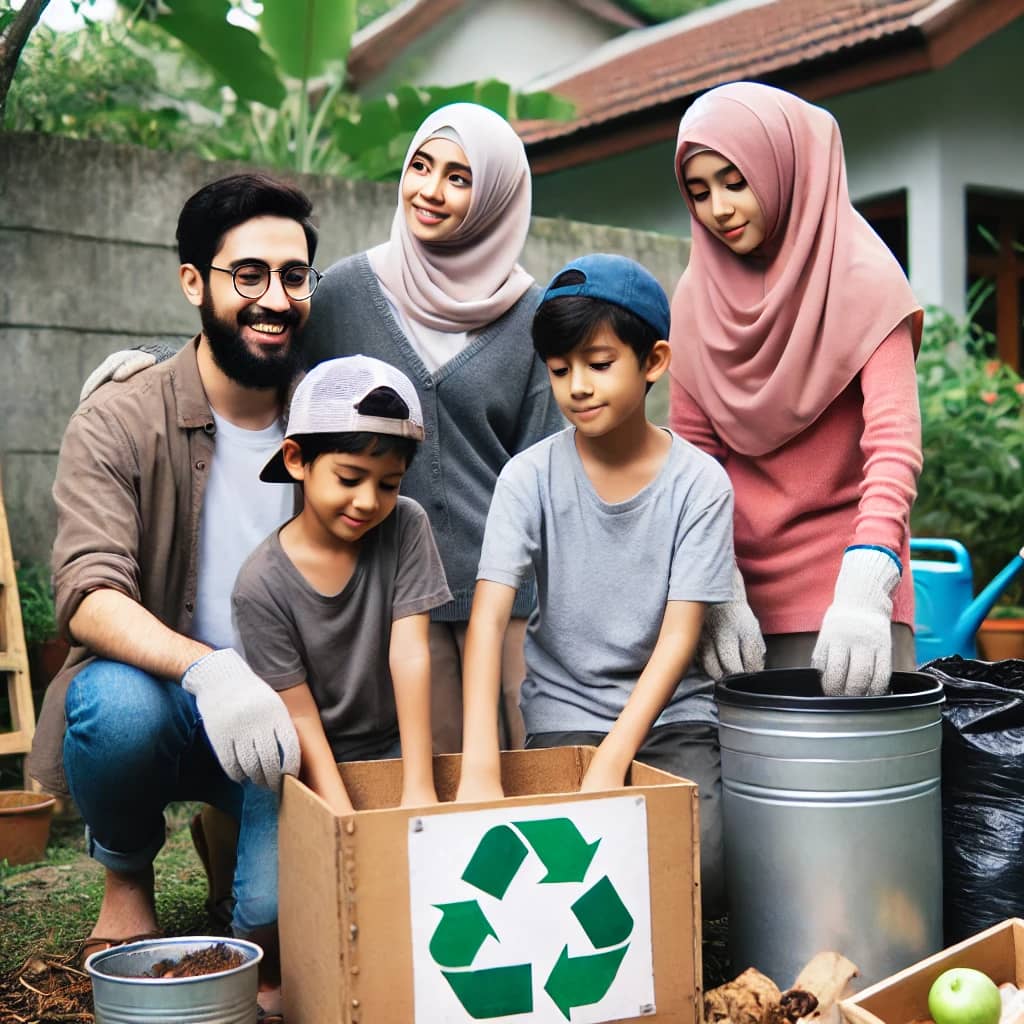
[199, 299, 302, 388]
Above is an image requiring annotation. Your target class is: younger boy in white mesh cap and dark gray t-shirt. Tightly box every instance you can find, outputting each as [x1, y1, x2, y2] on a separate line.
[231, 355, 452, 999]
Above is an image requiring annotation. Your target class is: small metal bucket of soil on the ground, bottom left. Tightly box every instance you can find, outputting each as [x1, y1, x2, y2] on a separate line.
[85, 935, 263, 1024]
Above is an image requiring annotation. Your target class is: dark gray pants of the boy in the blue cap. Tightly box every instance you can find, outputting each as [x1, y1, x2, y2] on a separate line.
[526, 725, 725, 921]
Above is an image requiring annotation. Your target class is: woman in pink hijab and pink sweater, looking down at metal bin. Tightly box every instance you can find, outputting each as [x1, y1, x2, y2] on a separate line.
[670, 82, 922, 694]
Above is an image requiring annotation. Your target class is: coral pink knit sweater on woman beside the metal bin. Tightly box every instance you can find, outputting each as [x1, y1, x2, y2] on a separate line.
[670, 324, 922, 635]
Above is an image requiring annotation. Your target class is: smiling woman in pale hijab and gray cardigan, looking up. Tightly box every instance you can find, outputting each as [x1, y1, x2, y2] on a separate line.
[305, 103, 564, 752]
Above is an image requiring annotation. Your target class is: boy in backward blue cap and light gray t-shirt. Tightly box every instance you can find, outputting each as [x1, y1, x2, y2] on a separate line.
[459, 254, 733, 915]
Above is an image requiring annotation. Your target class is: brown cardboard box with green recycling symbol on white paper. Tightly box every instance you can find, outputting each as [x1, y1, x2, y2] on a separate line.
[280, 746, 701, 1024]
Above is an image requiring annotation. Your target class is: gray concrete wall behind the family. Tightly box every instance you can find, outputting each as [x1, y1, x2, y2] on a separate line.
[0, 134, 688, 561]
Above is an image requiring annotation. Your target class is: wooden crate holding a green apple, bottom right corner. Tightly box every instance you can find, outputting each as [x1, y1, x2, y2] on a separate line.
[839, 918, 1024, 1024]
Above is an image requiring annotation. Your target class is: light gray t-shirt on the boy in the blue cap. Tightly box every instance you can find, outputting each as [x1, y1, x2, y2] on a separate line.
[477, 428, 733, 733]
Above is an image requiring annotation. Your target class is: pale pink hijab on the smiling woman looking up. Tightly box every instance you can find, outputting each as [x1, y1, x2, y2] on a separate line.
[368, 103, 534, 334]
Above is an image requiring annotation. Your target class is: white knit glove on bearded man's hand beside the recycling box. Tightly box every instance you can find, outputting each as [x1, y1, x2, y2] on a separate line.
[181, 647, 299, 793]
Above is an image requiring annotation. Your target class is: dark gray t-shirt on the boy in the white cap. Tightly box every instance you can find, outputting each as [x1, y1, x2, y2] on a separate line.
[231, 497, 452, 761]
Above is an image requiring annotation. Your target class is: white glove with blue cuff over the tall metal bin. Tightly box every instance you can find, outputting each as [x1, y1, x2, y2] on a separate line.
[811, 546, 902, 696]
